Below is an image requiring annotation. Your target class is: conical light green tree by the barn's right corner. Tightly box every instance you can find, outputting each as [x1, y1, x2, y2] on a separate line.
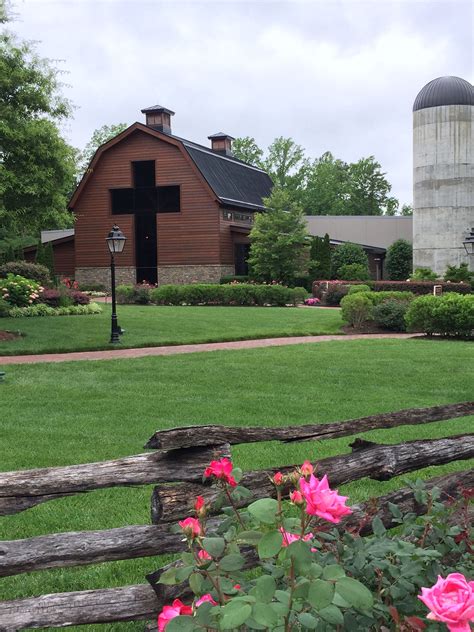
[248, 188, 309, 284]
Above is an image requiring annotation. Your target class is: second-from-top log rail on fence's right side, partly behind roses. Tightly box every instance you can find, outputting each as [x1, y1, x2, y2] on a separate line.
[151, 435, 474, 524]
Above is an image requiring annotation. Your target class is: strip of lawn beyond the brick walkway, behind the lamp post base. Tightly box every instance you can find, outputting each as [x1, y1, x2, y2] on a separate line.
[0, 305, 342, 355]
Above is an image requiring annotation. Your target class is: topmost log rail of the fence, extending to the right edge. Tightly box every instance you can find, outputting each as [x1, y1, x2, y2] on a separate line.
[145, 402, 474, 450]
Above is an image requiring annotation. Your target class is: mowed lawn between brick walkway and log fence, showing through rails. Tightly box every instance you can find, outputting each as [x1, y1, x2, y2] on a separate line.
[0, 338, 474, 632]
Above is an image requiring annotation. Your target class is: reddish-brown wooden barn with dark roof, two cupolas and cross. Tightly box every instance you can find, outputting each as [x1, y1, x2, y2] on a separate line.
[68, 105, 272, 286]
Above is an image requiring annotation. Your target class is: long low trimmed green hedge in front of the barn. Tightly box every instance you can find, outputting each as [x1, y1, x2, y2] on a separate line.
[117, 283, 307, 306]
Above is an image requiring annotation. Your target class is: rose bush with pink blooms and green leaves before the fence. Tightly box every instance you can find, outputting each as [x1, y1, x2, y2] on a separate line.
[156, 458, 474, 632]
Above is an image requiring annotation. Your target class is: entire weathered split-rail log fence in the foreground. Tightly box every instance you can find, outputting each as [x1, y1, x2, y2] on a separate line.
[0, 402, 474, 632]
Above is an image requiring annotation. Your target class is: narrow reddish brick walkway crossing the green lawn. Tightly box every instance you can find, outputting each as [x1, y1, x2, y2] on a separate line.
[0, 334, 419, 365]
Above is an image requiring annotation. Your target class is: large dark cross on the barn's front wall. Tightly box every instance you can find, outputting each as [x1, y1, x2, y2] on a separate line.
[109, 160, 181, 284]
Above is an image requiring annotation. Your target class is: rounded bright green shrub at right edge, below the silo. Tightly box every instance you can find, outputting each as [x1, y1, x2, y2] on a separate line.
[406, 293, 474, 338]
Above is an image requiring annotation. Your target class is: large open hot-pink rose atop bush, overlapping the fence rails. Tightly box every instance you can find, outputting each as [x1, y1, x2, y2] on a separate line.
[300, 475, 352, 524]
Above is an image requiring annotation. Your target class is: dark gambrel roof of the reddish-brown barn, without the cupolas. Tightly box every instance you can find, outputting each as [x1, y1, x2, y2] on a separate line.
[69, 123, 273, 211]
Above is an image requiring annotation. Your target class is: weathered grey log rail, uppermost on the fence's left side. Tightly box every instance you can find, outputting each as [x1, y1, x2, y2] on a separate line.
[0, 445, 230, 516]
